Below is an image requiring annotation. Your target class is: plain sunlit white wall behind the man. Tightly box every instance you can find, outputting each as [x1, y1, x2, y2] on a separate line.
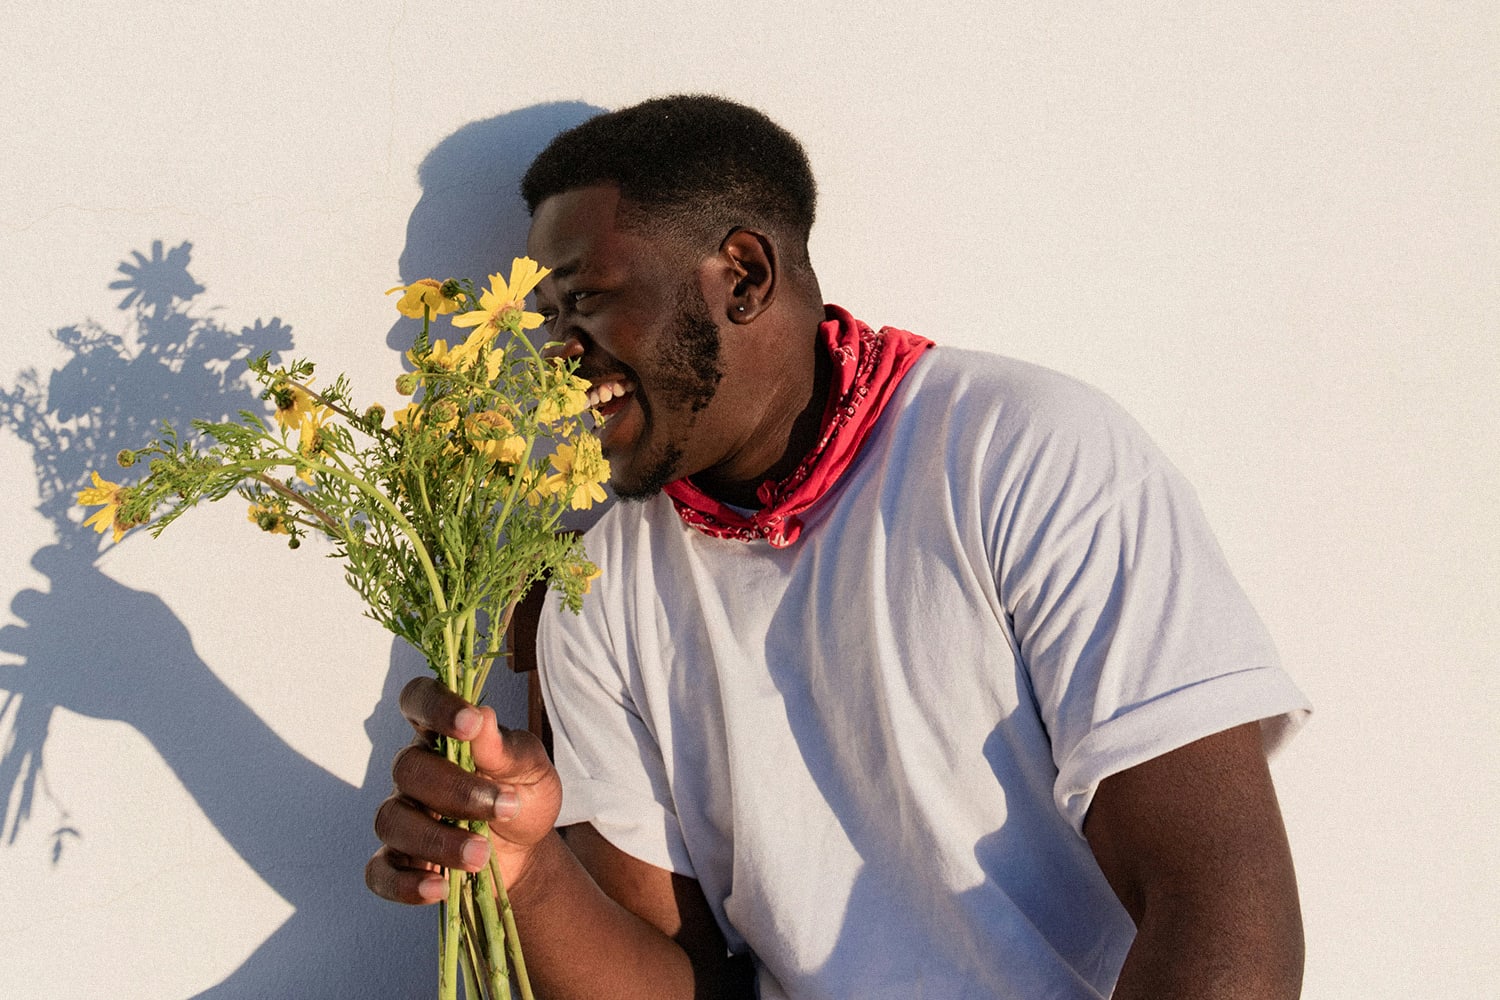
[0, 0, 1500, 1000]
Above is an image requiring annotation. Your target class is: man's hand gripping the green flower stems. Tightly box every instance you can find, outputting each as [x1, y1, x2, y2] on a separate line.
[365, 678, 563, 904]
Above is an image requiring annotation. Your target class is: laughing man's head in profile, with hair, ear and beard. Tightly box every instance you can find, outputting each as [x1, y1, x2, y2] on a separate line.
[522, 96, 822, 502]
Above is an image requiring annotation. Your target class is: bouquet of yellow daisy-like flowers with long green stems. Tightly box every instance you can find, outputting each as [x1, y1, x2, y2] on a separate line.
[78, 258, 609, 1000]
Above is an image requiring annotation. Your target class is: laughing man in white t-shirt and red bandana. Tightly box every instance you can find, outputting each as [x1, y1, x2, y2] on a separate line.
[368, 97, 1307, 1000]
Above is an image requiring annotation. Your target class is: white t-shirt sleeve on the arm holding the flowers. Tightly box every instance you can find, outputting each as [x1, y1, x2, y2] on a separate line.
[537, 589, 695, 877]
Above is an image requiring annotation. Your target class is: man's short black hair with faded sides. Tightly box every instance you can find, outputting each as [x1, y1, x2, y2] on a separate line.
[521, 94, 818, 276]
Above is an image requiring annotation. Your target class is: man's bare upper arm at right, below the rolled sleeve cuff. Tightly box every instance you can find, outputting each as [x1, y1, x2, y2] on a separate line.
[1083, 723, 1302, 1000]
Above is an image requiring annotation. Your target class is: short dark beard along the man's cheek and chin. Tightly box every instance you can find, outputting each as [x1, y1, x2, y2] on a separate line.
[615, 280, 725, 501]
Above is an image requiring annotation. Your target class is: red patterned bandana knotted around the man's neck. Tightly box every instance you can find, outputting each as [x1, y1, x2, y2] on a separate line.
[666, 306, 933, 549]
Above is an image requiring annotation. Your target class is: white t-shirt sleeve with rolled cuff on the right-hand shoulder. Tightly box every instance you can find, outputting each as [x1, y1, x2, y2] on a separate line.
[996, 389, 1310, 834]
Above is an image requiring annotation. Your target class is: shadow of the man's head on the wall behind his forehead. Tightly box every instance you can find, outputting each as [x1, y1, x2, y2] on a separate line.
[386, 100, 603, 351]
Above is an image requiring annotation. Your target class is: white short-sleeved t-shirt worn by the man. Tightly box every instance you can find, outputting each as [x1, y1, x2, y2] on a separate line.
[542, 348, 1308, 1000]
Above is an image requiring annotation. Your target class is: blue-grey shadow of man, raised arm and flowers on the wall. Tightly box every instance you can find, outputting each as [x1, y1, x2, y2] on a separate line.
[0, 103, 597, 1000]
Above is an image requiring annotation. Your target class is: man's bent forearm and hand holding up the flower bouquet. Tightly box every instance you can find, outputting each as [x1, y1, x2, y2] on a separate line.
[365, 678, 753, 1000]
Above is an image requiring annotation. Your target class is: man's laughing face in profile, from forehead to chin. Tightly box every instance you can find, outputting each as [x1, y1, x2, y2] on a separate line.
[527, 186, 723, 499]
